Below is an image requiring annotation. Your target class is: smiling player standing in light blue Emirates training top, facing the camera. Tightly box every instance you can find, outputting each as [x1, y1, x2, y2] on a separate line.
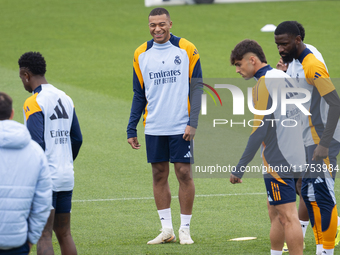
[127, 8, 202, 244]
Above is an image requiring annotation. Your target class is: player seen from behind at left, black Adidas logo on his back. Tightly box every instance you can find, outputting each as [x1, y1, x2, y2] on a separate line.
[18, 52, 82, 255]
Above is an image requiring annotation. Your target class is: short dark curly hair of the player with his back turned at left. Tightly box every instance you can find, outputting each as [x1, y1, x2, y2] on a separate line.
[18, 51, 46, 75]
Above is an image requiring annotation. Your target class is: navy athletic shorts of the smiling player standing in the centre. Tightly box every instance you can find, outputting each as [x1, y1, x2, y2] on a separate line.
[145, 135, 194, 163]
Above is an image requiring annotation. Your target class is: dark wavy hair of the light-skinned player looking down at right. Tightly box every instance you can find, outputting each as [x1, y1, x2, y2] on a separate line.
[230, 39, 267, 65]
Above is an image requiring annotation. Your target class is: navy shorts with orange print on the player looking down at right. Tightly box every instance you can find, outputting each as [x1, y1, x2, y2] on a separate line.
[264, 174, 296, 205]
